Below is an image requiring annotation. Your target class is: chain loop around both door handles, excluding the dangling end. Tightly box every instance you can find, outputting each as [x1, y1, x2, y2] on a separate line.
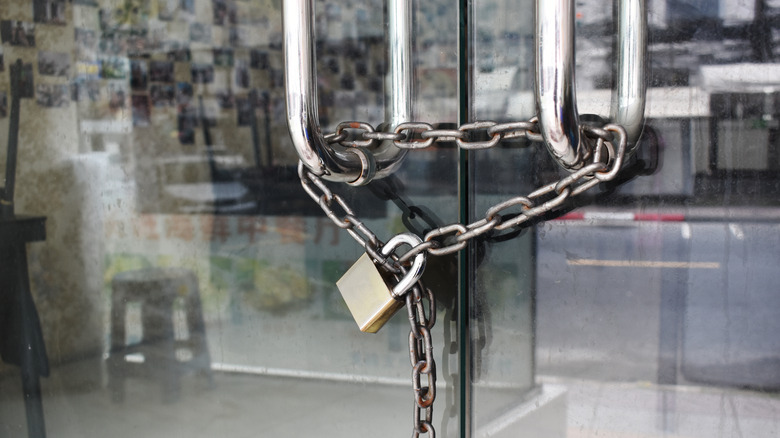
[298, 119, 626, 266]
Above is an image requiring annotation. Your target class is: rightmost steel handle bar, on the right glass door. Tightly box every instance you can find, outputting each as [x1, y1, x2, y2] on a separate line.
[611, 0, 647, 150]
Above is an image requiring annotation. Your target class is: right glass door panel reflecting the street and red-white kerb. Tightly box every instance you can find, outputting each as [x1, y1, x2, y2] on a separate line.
[470, 0, 780, 437]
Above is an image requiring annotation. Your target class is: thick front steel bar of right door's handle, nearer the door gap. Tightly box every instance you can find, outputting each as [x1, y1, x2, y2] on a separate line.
[535, 0, 582, 170]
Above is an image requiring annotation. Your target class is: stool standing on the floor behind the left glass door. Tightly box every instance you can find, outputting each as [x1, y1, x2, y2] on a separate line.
[108, 268, 214, 402]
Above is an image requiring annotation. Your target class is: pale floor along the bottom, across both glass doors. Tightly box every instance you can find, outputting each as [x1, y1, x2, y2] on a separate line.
[0, 358, 780, 438]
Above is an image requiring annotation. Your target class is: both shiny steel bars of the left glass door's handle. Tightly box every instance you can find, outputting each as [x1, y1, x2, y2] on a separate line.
[282, 0, 413, 184]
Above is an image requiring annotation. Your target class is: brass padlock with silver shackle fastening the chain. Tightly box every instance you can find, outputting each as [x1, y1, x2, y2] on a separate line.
[336, 234, 425, 333]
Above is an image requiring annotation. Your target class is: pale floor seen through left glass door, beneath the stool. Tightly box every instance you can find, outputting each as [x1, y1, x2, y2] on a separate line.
[0, 362, 411, 438]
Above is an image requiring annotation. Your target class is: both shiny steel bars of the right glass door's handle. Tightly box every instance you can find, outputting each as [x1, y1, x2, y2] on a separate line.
[535, 0, 647, 171]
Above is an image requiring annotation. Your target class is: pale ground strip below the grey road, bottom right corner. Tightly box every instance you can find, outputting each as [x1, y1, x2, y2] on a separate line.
[558, 381, 780, 438]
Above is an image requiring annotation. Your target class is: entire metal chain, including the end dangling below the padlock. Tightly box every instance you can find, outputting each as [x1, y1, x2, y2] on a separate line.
[298, 118, 626, 438]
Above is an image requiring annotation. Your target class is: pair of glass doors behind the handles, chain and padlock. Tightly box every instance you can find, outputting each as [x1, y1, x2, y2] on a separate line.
[0, 0, 780, 438]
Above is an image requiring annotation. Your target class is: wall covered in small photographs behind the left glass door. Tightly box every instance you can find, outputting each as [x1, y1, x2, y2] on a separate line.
[0, 0, 420, 212]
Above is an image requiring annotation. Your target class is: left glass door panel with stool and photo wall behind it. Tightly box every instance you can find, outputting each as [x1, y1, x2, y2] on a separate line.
[0, 0, 461, 437]
